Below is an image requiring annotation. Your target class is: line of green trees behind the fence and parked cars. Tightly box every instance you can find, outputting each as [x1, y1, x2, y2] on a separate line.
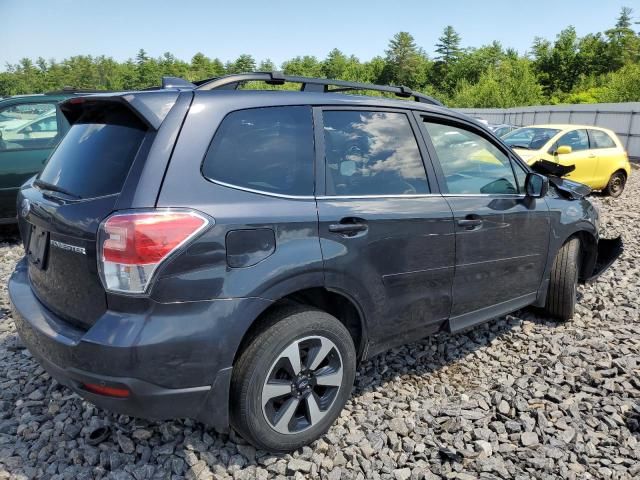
[0, 7, 640, 107]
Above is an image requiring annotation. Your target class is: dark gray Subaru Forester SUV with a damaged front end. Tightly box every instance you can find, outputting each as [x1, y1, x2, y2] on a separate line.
[9, 73, 622, 452]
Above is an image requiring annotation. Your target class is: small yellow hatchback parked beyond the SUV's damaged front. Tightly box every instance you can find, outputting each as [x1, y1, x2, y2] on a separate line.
[502, 125, 631, 197]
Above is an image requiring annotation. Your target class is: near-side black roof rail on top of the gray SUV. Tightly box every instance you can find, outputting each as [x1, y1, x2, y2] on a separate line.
[195, 72, 442, 106]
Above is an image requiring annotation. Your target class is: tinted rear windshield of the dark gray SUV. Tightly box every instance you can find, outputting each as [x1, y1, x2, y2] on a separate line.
[39, 104, 146, 198]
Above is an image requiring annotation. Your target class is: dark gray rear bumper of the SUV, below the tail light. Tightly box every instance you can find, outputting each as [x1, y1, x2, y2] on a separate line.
[9, 260, 269, 432]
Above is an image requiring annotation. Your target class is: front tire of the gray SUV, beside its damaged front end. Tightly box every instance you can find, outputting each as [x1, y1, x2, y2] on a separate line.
[545, 238, 580, 321]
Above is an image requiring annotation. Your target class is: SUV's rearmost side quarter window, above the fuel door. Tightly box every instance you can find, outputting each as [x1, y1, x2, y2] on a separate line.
[202, 107, 314, 195]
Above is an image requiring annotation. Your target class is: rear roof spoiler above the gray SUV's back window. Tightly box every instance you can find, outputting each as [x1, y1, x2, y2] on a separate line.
[60, 90, 186, 130]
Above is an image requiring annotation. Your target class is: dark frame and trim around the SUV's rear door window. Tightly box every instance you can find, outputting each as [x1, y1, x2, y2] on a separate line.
[313, 105, 432, 200]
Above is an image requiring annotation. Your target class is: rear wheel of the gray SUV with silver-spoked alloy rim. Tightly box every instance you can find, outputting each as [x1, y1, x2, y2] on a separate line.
[230, 306, 356, 453]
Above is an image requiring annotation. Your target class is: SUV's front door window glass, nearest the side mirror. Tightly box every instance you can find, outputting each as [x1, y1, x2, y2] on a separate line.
[424, 121, 518, 194]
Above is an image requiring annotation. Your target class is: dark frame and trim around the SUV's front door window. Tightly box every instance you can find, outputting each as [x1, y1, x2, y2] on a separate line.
[414, 111, 531, 198]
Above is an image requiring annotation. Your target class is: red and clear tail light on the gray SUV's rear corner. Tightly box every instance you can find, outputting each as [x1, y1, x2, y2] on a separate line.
[98, 210, 209, 293]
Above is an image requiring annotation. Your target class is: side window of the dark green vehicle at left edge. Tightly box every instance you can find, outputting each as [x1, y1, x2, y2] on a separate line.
[0, 103, 60, 151]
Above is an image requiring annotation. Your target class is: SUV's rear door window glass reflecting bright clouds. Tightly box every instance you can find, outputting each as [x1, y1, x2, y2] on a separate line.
[323, 111, 429, 195]
